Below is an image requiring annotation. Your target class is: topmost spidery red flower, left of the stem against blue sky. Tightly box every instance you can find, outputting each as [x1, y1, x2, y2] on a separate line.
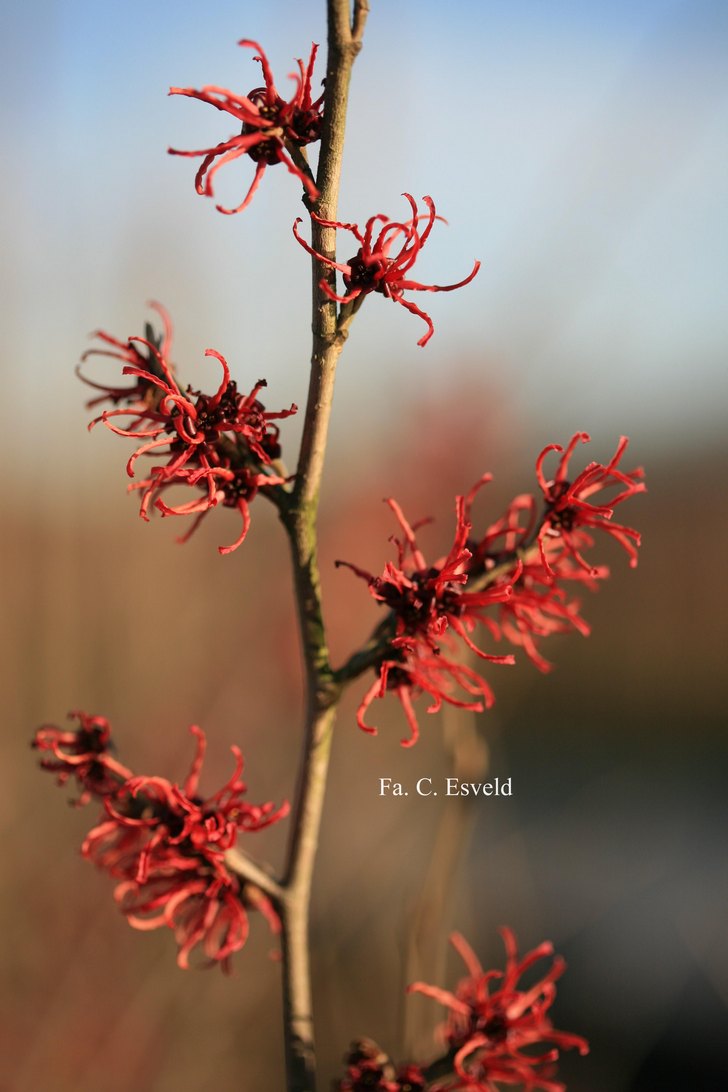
[168, 38, 324, 215]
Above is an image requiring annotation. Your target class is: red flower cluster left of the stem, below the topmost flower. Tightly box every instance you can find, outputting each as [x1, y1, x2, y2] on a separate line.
[82, 305, 297, 554]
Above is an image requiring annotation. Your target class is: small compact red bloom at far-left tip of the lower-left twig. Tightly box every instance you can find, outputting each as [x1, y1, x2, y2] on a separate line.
[32, 711, 131, 805]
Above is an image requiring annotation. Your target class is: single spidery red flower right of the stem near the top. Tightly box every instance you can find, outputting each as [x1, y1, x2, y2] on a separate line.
[294, 193, 480, 345]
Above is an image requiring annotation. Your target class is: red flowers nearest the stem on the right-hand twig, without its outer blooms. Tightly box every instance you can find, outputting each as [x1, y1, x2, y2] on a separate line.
[336, 497, 514, 747]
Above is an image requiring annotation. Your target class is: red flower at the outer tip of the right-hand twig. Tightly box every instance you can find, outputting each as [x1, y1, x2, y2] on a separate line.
[536, 432, 645, 575]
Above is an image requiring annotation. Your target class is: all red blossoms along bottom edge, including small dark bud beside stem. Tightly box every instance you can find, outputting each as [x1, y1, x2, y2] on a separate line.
[336, 928, 588, 1092]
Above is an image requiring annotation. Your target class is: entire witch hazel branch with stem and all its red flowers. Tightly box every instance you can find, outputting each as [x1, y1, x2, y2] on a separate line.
[34, 0, 645, 1092]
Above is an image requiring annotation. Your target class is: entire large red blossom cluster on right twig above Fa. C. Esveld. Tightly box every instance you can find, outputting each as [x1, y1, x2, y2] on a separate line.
[337, 432, 645, 746]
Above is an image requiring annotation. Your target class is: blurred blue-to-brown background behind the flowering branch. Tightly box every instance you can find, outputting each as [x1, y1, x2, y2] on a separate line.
[0, 0, 728, 1092]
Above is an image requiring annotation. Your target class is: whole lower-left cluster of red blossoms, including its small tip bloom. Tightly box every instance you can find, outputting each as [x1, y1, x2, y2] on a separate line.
[33, 712, 289, 971]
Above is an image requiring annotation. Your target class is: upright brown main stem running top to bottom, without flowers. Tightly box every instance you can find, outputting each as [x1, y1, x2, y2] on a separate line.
[279, 0, 368, 1092]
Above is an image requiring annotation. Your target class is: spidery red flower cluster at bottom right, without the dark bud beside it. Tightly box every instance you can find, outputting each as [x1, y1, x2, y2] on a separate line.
[408, 928, 588, 1092]
